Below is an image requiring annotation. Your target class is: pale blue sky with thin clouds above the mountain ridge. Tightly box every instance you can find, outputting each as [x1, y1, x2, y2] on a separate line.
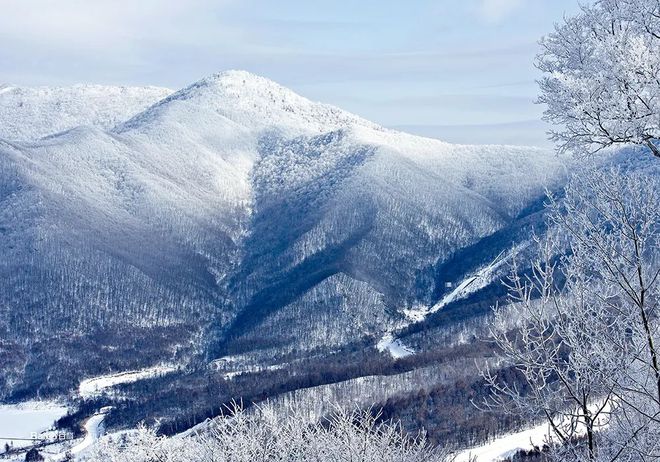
[0, 0, 578, 144]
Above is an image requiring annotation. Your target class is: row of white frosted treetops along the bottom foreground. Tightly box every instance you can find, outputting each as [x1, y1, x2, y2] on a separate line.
[85, 406, 448, 462]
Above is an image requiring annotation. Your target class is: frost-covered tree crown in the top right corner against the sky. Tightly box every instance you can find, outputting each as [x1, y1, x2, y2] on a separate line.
[537, 0, 660, 157]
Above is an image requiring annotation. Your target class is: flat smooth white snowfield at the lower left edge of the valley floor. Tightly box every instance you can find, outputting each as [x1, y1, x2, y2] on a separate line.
[0, 401, 67, 454]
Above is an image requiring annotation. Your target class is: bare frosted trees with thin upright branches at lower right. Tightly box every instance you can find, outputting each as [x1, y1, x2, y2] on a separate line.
[485, 170, 660, 461]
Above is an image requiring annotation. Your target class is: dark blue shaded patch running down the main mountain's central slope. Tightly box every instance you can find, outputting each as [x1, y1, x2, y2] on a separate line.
[210, 130, 376, 357]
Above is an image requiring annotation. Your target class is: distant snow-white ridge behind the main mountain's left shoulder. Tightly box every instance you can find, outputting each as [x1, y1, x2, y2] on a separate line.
[0, 85, 172, 140]
